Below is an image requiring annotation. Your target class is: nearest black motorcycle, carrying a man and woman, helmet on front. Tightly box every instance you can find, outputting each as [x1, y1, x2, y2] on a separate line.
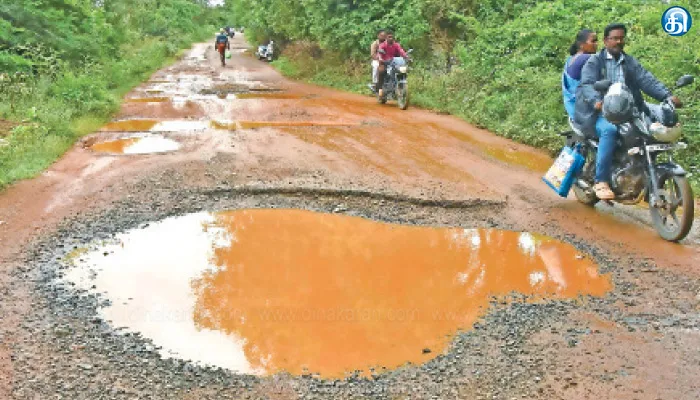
[561, 75, 694, 242]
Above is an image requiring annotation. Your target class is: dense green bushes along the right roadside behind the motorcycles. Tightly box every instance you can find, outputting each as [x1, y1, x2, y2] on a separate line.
[226, 0, 700, 194]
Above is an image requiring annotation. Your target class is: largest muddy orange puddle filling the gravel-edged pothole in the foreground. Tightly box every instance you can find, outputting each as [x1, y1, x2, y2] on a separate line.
[66, 209, 611, 378]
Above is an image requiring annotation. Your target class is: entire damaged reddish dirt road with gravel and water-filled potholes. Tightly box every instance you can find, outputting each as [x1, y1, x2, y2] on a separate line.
[0, 36, 700, 400]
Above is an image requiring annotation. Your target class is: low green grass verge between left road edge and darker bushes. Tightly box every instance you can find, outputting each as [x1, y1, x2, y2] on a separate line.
[0, 26, 214, 188]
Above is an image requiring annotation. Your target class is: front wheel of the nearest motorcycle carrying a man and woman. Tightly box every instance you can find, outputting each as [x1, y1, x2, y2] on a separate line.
[649, 175, 695, 242]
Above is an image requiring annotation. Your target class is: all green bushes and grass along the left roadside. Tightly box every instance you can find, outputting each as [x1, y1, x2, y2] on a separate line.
[0, 0, 224, 188]
